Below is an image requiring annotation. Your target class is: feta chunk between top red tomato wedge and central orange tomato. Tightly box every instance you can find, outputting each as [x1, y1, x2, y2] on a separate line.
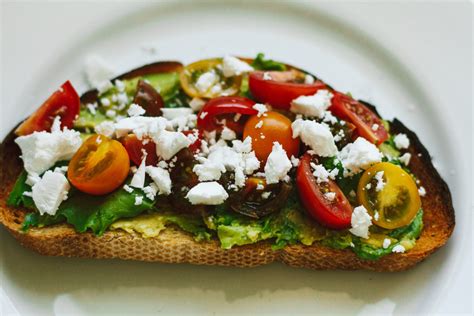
[290, 90, 334, 118]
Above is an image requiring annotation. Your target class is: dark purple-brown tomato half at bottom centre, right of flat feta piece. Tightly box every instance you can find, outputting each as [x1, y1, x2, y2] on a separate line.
[229, 178, 291, 218]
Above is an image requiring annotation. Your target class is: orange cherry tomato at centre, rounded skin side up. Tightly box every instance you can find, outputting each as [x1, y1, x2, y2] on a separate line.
[243, 111, 300, 162]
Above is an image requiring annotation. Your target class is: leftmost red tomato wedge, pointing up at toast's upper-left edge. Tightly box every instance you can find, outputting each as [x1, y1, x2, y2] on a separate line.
[15, 80, 81, 135]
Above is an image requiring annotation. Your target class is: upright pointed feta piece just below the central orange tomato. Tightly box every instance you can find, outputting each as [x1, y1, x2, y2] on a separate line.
[264, 142, 292, 184]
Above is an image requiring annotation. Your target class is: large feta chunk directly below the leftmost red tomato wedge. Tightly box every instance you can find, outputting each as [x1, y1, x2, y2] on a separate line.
[15, 128, 82, 175]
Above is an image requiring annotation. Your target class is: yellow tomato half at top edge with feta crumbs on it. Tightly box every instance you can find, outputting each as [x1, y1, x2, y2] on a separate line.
[179, 58, 242, 98]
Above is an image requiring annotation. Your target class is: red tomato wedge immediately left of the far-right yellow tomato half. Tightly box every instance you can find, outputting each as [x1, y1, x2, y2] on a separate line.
[296, 154, 352, 229]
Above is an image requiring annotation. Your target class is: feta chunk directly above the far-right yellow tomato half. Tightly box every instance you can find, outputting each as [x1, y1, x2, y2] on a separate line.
[339, 137, 382, 177]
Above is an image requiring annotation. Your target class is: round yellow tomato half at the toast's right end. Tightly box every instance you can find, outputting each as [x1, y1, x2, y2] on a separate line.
[357, 162, 421, 229]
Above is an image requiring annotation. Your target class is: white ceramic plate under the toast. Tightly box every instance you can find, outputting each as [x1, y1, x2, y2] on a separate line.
[0, 1, 472, 315]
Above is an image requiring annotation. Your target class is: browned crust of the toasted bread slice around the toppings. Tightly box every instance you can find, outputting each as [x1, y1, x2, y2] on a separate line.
[0, 119, 454, 271]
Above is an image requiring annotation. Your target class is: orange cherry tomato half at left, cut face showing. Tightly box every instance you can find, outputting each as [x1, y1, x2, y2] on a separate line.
[67, 135, 130, 195]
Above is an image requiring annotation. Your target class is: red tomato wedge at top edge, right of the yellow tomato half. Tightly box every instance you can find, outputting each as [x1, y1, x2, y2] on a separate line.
[249, 71, 327, 110]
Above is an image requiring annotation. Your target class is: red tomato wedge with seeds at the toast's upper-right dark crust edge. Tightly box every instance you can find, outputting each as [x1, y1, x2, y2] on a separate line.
[329, 91, 388, 145]
